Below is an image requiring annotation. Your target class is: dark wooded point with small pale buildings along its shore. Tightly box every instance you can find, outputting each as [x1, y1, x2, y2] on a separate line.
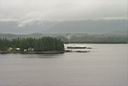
[0, 37, 64, 54]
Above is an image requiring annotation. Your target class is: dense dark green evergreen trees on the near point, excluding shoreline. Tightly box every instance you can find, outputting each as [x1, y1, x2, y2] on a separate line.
[0, 37, 64, 51]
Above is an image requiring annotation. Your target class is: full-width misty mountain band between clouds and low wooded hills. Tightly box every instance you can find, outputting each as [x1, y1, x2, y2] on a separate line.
[0, 19, 128, 34]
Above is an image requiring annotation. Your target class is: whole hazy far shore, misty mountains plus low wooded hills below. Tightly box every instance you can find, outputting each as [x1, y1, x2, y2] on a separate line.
[0, 19, 128, 43]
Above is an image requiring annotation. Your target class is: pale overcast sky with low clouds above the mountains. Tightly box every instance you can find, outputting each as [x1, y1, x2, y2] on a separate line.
[0, 0, 128, 21]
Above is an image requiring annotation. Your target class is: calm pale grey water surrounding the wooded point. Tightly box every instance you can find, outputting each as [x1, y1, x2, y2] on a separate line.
[0, 44, 128, 86]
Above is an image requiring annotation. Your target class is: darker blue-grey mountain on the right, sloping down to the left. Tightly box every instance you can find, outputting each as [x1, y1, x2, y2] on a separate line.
[47, 20, 128, 34]
